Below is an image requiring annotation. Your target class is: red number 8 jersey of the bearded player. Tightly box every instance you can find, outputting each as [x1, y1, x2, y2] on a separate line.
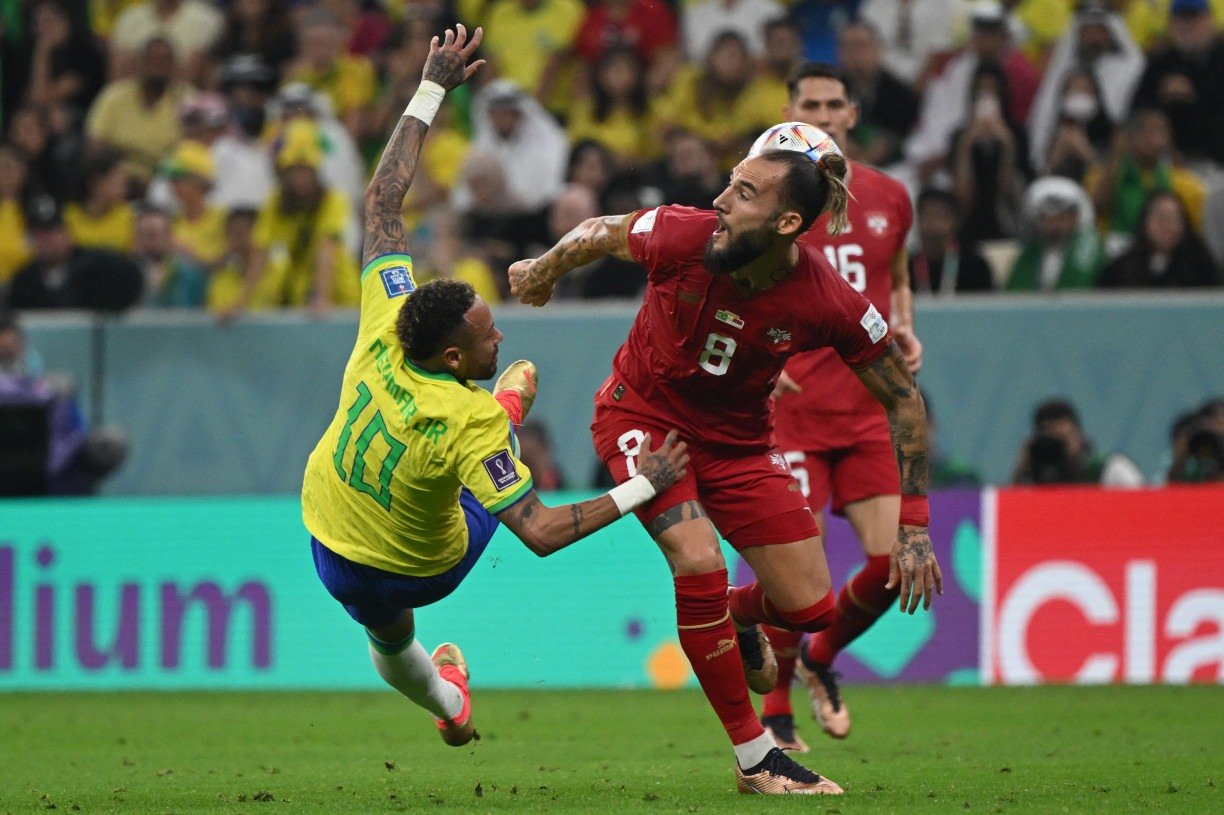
[596, 201, 892, 452]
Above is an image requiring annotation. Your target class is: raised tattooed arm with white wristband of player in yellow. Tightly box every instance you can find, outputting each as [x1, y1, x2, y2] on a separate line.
[361, 24, 485, 267]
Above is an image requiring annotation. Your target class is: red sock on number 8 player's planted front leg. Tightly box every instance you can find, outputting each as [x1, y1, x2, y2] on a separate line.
[674, 569, 765, 744]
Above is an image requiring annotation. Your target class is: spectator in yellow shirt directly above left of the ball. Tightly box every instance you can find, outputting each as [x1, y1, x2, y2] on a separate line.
[659, 31, 780, 169]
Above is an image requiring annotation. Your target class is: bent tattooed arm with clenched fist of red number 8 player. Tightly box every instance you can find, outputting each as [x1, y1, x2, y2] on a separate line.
[509, 214, 633, 306]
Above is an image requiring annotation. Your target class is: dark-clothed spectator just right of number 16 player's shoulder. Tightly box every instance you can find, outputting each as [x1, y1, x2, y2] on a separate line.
[909, 187, 994, 292]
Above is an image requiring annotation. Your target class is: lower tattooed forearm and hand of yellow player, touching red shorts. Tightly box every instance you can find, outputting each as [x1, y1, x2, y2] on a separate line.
[497, 431, 688, 557]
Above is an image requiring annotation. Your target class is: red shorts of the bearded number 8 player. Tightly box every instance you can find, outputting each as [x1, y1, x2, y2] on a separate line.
[592, 406, 820, 549]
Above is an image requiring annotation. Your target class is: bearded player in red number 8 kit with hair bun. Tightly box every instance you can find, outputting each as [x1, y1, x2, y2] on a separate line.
[509, 128, 941, 794]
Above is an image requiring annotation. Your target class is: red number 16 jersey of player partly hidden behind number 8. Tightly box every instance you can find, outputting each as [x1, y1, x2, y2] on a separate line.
[775, 162, 913, 450]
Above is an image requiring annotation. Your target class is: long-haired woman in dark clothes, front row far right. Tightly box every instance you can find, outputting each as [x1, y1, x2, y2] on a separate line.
[1097, 191, 1220, 289]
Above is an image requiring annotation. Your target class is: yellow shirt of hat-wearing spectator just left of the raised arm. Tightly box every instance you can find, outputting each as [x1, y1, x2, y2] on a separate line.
[252, 190, 361, 308]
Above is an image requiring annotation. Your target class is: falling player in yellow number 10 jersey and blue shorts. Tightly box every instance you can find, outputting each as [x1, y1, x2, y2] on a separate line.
[302, 26, 688, 746]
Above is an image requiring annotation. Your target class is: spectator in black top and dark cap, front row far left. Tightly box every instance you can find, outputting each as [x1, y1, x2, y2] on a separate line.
[9, 196, 141, 311]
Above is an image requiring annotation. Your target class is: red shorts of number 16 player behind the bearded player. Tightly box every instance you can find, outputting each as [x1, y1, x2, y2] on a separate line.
[786, 425, 901, 515]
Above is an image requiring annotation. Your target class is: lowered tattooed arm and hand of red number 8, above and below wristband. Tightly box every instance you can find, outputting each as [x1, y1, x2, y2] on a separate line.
[856, 344, 944, 614]
